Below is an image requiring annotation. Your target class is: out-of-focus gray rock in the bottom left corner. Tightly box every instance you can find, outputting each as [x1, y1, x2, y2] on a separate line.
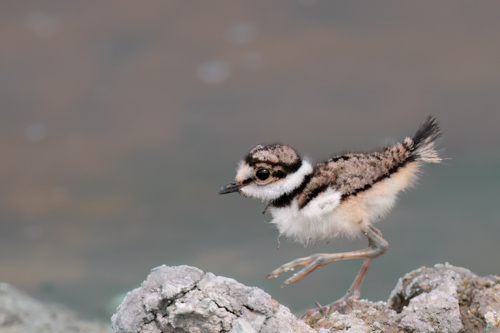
[0, 283, 110, 333]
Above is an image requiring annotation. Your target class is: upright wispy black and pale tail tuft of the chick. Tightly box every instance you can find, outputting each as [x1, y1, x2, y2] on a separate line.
[405, 116, 442, 163]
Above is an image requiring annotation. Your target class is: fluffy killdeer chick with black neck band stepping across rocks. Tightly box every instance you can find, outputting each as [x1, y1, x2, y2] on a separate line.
[219, 116, 441, 315]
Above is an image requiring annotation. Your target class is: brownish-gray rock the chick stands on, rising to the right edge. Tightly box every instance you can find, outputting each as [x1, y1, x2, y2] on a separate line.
[310, 264, 500, 333]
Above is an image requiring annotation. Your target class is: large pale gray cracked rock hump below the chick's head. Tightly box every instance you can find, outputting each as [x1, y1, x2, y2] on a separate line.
[111, 266, 314, 333]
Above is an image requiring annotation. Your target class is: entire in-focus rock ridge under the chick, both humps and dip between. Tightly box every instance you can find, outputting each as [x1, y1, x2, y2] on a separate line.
[112, 264, 500, 333]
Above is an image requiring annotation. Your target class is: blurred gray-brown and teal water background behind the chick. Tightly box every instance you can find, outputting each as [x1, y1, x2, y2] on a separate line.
[0, 0, 500, 321]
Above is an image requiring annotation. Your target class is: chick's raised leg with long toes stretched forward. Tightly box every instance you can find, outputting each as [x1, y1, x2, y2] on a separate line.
[266, 226, 389, 287]
